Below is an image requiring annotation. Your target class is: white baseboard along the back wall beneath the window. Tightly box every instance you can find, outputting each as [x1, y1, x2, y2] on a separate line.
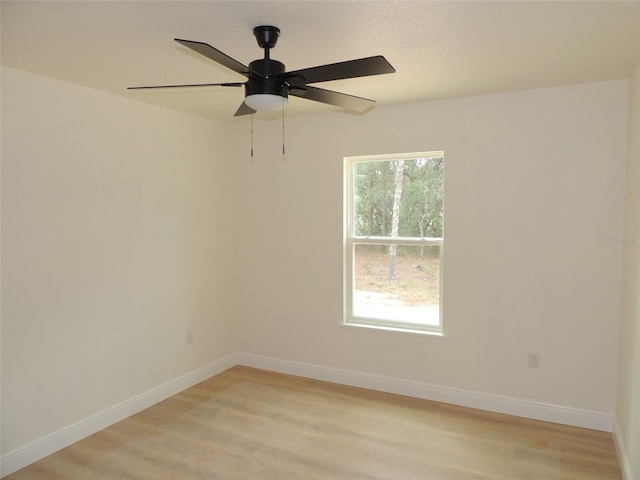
[236, 353, 613, 432]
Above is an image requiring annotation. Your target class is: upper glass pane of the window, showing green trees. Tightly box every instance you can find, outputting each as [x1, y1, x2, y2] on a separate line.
[353, 157, 444, 237]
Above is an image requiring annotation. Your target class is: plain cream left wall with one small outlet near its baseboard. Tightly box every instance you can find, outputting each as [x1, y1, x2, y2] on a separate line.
[2, 68, 237, 452]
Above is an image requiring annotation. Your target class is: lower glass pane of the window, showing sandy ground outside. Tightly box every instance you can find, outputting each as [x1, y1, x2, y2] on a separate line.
[353, 244, 440, 326]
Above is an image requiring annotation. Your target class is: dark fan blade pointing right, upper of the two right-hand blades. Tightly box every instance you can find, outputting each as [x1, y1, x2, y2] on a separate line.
[279, 55, 396, 86]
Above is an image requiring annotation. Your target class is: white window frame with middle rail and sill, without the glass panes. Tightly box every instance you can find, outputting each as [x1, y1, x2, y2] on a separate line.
[342, 150, 444, 336]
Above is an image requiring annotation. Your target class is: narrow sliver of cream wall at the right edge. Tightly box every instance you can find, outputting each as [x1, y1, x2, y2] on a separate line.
[616, 35, 640, 480]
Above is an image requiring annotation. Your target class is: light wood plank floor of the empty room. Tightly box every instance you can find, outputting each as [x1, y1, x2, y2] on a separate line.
[6, 367, 622, 480]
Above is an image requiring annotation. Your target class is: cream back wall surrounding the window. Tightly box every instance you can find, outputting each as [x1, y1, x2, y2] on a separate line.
[236, 81, 627, 415]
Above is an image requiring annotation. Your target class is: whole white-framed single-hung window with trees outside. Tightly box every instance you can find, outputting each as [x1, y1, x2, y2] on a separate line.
[344, 152, 444, 334]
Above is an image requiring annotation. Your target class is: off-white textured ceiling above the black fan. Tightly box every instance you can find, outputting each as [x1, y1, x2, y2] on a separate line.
[0, 0, 640, 121]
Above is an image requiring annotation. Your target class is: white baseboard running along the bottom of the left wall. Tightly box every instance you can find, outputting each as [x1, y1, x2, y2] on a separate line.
[0, 354, 237, 477]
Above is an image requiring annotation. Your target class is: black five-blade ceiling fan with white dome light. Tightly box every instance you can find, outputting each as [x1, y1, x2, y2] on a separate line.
[129, 25, 395, 117]
